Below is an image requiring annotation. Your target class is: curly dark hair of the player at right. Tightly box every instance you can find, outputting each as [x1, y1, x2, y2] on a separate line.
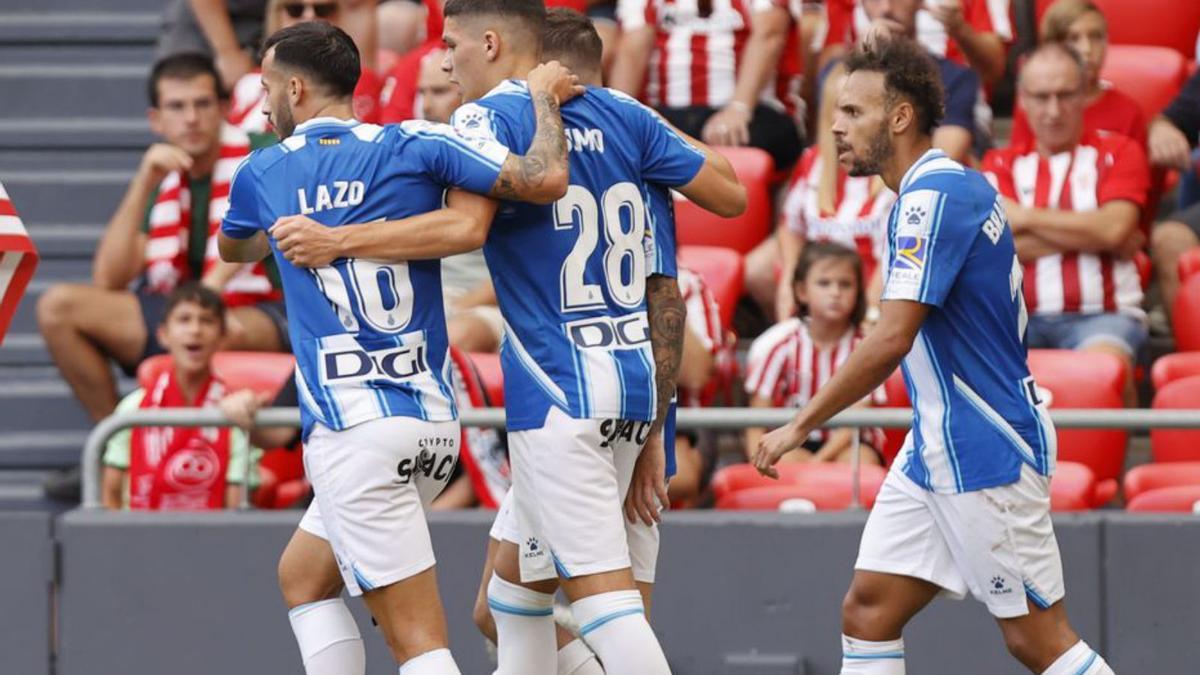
[846, 37, 946, 136]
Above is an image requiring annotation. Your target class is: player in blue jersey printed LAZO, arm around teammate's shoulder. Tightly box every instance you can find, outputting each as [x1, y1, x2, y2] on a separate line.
[220, 22, 585, 675]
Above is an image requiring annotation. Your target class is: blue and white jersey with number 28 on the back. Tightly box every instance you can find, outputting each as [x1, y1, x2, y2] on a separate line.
[451, 80, 704, 430]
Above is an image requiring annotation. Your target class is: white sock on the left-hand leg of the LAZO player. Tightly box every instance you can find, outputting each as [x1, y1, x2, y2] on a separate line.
[288, 598, 367, 675]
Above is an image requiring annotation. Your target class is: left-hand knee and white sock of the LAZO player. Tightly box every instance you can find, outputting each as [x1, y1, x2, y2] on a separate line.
[278, 528, 366, 675]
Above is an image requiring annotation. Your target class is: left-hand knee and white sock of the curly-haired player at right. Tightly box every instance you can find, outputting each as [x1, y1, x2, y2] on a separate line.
[841, 571, 941, 675]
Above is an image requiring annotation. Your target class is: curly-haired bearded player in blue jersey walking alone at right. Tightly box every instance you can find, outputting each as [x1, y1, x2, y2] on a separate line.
[755, 38, 1112, 675]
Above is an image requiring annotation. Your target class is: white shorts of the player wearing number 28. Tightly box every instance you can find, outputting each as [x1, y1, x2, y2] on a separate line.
[501, 407, 659, 583]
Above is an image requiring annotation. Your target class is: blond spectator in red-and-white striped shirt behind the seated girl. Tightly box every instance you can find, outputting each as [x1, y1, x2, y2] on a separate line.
[745, 65, 895, 321]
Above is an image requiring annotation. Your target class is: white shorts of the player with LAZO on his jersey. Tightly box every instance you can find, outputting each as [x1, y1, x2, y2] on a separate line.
[300, 417, 462, 596]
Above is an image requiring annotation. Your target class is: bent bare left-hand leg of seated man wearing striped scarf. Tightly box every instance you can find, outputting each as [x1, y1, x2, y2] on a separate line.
[37, 283, 149, 420]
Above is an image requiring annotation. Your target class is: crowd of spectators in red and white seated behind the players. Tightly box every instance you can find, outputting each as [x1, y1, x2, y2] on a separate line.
[46, 0, 1200, 506]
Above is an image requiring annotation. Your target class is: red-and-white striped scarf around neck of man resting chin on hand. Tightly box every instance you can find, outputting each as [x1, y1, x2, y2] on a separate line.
[146, 125, 280, 306]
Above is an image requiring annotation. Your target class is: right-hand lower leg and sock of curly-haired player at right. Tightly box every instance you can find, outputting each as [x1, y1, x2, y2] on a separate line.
[996, 601, 1112, 675]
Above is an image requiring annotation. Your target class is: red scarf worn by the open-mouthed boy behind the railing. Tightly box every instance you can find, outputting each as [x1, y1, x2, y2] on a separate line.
[130, 368, 230, 510]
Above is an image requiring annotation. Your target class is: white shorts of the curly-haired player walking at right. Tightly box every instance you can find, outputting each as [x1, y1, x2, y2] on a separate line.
[854, 466, 1066, 619]
